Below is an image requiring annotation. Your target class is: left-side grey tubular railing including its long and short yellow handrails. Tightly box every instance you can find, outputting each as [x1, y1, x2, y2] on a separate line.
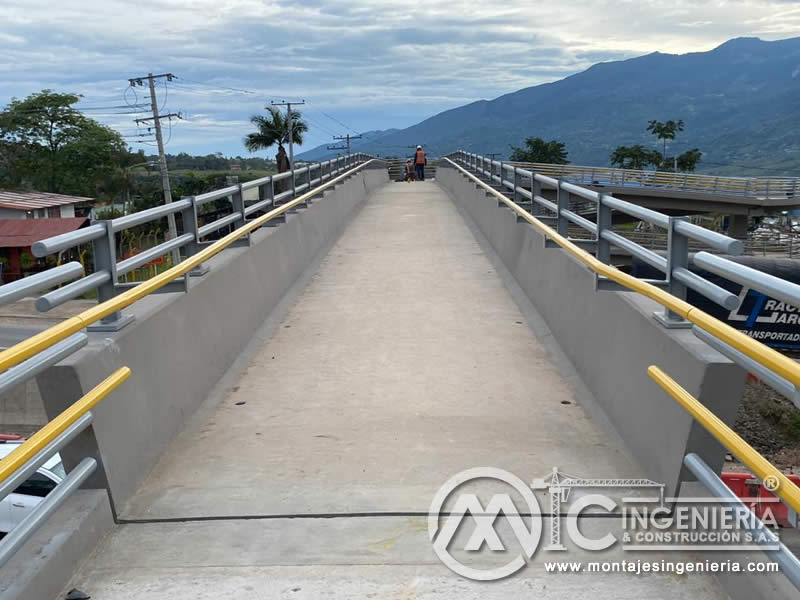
[0, 155, 371, 567]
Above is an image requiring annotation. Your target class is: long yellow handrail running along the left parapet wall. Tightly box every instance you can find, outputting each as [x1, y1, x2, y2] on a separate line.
[0, 160, 372, 371]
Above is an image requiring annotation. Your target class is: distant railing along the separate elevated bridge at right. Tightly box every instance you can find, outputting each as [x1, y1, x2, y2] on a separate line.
[504, 161, 800, 202]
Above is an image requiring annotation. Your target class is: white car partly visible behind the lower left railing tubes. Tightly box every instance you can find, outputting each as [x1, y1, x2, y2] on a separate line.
[0, 441, 67, 537]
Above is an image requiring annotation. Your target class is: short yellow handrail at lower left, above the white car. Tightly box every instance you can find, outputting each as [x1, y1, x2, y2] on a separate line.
[0, 367, 131, 483]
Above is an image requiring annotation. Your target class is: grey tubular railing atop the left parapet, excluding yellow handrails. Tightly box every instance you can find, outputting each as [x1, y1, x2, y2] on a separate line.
[0, 154, 368, 331]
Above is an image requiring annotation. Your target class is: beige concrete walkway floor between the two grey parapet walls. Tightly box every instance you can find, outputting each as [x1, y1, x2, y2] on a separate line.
[61, 182, 725, 600]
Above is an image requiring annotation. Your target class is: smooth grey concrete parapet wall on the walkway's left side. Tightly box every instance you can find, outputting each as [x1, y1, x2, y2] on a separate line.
[38, 168, 388, 510]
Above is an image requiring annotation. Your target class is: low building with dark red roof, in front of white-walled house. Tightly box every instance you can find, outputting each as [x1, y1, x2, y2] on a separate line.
[0, 217, 89, 283]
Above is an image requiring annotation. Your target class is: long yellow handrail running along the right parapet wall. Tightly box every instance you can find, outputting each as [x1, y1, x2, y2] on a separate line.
[446, 158, 800, 385]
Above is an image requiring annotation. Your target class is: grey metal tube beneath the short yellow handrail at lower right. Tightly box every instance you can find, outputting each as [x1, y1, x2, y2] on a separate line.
[683, 453, 800, 590]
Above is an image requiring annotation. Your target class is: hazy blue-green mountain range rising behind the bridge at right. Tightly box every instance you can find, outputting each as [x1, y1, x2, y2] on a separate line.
[298, 38, 800, 175]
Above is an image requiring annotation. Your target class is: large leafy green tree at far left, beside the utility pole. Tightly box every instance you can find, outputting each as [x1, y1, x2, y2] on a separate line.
[0, 90, 127, 195]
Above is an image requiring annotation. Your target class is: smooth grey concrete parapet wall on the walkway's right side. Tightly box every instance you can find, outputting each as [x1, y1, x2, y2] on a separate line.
[437, 166, 745, 492]
